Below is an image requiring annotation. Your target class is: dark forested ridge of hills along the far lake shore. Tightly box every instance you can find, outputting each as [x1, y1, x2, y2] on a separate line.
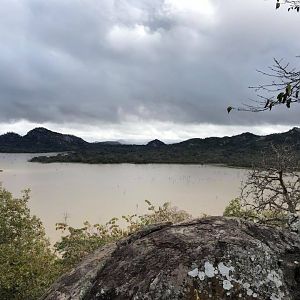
[0, 127, 300, 167]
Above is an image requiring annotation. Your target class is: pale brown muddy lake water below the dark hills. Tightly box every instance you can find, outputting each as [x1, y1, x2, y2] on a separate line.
[0, 153, 246, 242]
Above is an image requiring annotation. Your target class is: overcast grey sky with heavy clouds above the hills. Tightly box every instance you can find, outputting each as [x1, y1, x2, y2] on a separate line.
[0, 0, 300, 141]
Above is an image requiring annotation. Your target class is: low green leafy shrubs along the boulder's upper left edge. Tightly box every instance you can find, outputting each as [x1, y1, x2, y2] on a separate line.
[54, 200, 191, 270]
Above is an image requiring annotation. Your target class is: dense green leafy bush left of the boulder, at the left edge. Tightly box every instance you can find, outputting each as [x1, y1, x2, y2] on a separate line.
[0, 187, 59, 300]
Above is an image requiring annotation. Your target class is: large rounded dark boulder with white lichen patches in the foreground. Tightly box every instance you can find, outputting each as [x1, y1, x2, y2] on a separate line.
[43, 217, 300, 300]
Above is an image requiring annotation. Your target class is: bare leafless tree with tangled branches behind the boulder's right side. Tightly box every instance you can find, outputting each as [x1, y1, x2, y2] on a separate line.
[241, 145, 300, 223]
